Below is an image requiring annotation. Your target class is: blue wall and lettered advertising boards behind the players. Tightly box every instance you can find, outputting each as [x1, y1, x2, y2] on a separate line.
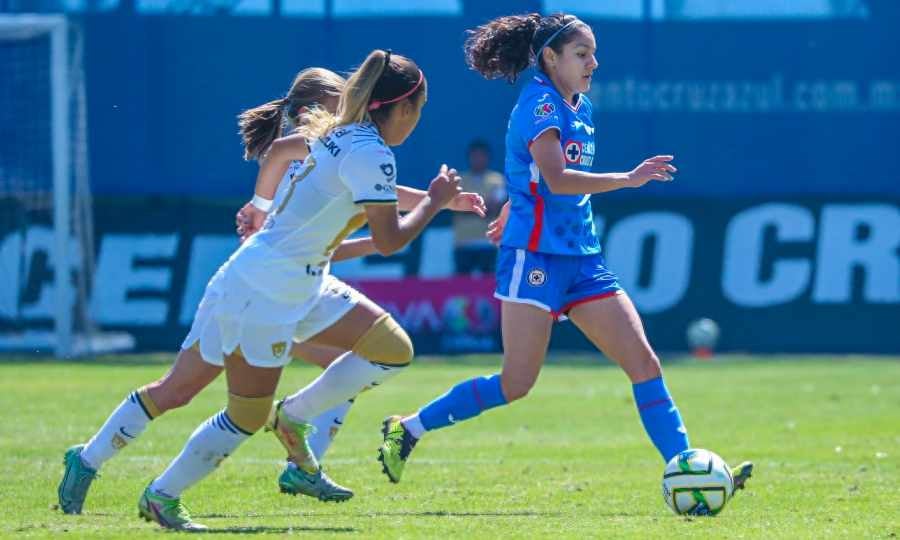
[0, 0, 900, 354]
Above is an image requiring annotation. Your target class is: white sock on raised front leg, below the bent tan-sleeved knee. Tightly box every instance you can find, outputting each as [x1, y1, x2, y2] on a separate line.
[281, 352, 405, 422]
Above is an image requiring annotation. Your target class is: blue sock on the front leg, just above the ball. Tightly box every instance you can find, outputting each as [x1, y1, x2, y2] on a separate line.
[632, 377, 690, 463]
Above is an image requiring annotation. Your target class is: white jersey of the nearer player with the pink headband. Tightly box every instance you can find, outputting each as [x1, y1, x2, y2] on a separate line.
[225, 123, 397, 304]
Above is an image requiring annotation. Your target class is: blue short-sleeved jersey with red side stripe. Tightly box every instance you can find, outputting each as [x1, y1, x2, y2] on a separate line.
[500, 72, 600, 255]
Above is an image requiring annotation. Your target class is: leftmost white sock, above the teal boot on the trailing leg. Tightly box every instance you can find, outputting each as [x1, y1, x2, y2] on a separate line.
[81, 390, 152, 470]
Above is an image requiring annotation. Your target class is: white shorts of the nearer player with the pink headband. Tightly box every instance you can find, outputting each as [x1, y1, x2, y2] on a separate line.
[181, 271, 363, 368]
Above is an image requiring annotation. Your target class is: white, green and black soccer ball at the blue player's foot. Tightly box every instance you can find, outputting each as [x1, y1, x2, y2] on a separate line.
[663, 448, 734, 516]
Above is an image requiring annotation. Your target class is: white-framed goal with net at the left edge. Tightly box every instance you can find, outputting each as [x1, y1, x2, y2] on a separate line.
[0, 14, 130, 357]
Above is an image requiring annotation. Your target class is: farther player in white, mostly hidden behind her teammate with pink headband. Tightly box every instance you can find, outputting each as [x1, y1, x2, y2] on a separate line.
[58, 68, 484, 514]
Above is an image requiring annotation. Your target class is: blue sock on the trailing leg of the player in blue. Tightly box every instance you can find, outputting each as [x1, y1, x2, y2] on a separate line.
[418, 374, 506, 431]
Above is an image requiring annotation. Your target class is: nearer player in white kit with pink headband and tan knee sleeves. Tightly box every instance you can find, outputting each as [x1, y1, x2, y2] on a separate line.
[139, 50, 460, 530]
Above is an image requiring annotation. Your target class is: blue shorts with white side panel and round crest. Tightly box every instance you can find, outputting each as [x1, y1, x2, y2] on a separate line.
[494, 246, 623, 319]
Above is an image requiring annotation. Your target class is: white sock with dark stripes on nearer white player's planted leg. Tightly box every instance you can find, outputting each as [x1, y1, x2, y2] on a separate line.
[150, 410, 250, 497]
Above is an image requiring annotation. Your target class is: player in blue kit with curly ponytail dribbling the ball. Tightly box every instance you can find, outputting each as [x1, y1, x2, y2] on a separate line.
[379, 13, 753, 489]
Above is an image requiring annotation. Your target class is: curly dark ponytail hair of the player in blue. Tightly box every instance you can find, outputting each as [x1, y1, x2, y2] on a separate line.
[463, 13, 584, 84]
